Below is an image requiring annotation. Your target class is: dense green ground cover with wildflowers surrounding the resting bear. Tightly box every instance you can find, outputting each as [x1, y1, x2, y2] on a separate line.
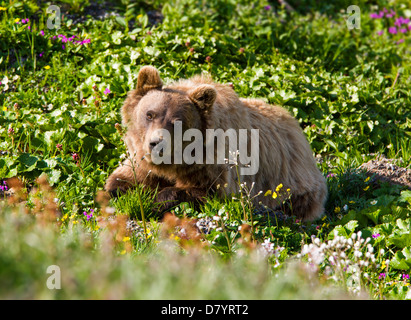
[0, 0, 411, 299]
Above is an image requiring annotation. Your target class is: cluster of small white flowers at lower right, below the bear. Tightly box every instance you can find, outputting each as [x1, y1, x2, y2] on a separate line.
[299, 231, 376, 294]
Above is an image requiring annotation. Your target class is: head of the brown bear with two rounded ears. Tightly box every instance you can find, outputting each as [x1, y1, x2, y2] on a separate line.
[122, 66, 217, 164]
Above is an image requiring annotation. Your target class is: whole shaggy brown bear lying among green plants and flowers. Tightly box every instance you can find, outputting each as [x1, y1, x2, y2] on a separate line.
[105, 66, 327, 220]
